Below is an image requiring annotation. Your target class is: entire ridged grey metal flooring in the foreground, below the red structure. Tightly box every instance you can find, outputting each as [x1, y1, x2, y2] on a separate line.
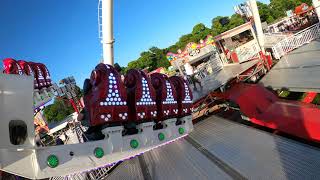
[107, 116, 320, 180]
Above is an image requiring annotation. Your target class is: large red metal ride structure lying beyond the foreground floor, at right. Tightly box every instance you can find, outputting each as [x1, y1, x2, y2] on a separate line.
[199, 83, 320, 142]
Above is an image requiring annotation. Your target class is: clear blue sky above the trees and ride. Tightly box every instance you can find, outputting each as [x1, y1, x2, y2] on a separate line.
[0, 0, 268, 86]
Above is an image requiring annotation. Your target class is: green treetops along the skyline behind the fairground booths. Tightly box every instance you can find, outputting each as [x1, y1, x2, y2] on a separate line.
[122, 0, 312, 72]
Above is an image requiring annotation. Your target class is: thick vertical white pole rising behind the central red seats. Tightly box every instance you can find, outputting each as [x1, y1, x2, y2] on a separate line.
[101, 0, 114, 65]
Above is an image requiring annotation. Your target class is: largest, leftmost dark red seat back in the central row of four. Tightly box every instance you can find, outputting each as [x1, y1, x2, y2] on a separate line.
[84, 63, 128, 126]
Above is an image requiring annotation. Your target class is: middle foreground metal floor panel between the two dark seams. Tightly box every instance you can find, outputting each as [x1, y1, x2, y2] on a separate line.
[144, 140, 231, 180]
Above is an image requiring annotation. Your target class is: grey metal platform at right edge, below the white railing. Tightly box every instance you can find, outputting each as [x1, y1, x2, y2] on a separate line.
[260, 39, 320, 92]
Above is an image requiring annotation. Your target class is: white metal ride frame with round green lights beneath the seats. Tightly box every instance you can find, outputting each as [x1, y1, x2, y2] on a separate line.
[0, 74, 193, 179]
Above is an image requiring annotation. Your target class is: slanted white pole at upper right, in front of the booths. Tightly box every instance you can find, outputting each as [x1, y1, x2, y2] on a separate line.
[249, 0, 265, 53]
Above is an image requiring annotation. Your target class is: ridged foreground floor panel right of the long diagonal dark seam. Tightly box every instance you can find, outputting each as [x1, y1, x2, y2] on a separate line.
[190, 116, 320, 179]
